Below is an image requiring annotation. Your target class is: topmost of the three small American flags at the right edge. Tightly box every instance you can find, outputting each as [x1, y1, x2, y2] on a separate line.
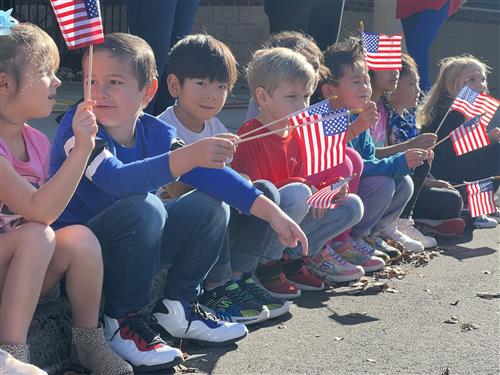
[451, 86, 500, 127]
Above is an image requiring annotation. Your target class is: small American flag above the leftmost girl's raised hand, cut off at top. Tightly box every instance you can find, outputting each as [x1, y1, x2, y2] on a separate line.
[50, 0, 104, 49]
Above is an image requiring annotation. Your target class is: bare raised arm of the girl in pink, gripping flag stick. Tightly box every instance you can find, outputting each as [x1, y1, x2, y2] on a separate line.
[0, 100, 97, 225]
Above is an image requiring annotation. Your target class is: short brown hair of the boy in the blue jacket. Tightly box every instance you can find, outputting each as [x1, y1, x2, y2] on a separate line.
[83, 33, 158, 90]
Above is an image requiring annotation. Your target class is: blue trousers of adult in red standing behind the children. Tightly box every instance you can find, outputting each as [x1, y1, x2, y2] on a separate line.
[401, 0, 450, 92]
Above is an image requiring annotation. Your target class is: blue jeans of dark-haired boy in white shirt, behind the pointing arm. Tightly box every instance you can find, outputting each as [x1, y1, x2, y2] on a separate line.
[206, 180, 280, 284]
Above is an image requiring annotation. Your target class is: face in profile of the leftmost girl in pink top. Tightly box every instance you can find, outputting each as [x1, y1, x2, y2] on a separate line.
[7, 64, 61, 122]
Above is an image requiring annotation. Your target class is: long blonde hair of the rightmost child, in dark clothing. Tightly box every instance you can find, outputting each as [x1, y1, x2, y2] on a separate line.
[417, 55, 490, 126]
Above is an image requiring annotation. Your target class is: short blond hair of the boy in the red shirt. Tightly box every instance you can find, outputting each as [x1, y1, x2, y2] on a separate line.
[246, 47, 318, 98]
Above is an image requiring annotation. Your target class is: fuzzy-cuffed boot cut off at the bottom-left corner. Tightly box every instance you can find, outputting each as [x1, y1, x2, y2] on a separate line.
[0, 345, 47, 375]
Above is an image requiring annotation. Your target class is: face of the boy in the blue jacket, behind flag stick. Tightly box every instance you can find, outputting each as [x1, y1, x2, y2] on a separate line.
[83, 51, 150, 131]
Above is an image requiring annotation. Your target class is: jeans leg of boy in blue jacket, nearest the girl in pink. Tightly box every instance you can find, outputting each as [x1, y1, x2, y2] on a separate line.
[87, 194, 167, 318]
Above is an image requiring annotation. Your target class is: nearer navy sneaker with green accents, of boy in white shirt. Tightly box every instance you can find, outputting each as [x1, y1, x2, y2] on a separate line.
[198, 281, 269, 325]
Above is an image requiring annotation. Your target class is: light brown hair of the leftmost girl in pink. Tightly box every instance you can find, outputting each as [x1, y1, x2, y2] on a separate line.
[0, 23, 59, 93]
